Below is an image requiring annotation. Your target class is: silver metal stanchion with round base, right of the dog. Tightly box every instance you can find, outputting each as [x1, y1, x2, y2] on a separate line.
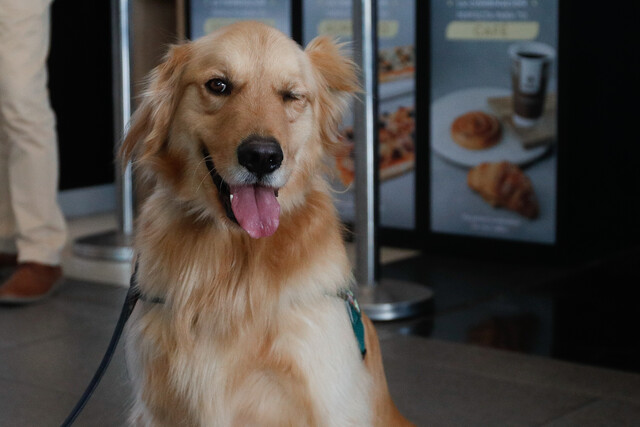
[352, 0, 433, 320]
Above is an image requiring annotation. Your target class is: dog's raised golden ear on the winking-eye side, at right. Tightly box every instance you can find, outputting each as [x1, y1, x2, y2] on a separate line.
[305, 36, 360, 154]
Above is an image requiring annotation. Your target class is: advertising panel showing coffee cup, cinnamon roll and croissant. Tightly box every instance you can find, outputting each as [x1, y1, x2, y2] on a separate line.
[429, 0, 561, 245]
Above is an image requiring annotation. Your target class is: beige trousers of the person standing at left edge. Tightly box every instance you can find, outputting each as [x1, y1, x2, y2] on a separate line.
[0, 0, 67, 265]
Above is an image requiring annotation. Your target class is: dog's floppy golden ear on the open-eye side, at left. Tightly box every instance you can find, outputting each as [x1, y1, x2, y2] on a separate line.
[120, 44, 190, 167]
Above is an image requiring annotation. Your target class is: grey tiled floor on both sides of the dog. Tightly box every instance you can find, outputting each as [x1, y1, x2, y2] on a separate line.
[0, 216, 640, 427]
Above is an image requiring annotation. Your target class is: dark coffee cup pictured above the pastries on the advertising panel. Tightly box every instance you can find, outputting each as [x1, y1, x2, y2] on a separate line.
[508, 42, 556, 127]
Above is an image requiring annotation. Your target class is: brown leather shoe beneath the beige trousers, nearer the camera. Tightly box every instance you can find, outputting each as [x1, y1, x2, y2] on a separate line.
[0, 262, 62, 305]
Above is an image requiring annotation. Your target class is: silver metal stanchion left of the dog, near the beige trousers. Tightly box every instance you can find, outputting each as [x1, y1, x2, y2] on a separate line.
[73, 0, 134, 261]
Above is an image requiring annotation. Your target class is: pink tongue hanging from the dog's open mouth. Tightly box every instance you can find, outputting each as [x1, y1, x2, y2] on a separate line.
[230, 185, 280, 239]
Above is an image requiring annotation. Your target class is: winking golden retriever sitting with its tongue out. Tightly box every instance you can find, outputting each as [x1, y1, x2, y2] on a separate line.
[122, 22, 410, 427]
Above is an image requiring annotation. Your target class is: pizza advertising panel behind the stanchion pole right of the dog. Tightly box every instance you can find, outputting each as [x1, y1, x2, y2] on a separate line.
[302, 0, 416, 230]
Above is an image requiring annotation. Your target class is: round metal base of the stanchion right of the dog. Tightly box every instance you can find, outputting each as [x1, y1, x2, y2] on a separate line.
[357, 279, 433, 320]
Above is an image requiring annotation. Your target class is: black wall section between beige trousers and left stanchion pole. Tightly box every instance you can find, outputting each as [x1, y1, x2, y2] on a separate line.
[48, 0, 114, 190]
